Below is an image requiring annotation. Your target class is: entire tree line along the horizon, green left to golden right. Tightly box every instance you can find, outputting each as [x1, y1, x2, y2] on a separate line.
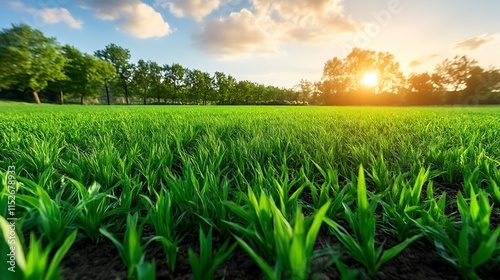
[0, 24, 500, 105]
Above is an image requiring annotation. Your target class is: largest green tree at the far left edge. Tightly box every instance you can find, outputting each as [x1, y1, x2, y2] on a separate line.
[0, 24, 66, 104]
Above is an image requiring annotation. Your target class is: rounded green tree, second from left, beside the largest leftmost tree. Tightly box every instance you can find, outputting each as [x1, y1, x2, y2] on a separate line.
[63, 45, 115, 105]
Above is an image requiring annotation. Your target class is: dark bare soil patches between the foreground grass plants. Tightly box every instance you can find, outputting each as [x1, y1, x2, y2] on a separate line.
[62, 185, 500, 280]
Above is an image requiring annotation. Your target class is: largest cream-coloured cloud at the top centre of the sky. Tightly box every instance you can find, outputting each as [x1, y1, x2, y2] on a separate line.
[196, 0, 360, 54]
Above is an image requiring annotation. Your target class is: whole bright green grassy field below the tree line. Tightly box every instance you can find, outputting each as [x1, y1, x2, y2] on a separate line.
[0, 105, 500, 279]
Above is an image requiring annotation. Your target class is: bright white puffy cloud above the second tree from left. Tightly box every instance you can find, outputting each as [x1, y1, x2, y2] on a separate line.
[82, 0, 172, 39]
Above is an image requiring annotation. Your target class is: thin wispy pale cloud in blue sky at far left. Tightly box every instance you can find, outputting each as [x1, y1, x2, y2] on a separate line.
[10, 1, 83, 29]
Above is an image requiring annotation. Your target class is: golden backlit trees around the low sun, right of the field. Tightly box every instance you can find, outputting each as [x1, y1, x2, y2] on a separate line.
[311, 48, 500, 105]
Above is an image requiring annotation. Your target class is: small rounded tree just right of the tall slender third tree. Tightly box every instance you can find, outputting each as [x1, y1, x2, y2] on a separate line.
[132, 59, 161, 105]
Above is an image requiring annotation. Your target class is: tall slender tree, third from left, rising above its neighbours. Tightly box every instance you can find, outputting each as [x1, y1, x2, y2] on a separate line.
[94, 43, 134, 105]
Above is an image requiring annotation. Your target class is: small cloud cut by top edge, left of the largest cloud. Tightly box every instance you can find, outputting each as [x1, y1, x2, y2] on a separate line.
[156, 0, 230, 21]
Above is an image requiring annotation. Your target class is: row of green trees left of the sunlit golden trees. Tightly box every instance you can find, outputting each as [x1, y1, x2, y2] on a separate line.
[0, 24, 299, 104]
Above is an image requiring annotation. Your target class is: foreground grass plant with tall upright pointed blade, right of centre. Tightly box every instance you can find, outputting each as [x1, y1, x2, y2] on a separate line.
[324, 166, 420, 277]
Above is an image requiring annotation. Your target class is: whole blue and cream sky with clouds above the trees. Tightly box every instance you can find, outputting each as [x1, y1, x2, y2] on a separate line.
[0, 0, 500, 87]
